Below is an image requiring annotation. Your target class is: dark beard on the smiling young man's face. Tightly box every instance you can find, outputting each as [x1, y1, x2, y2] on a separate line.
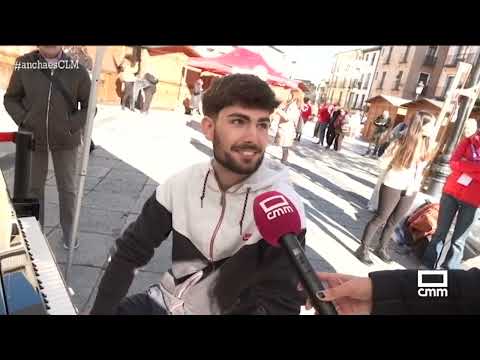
[213, 132, 265, 175]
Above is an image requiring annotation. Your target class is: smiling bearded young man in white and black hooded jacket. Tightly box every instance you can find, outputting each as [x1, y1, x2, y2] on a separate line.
[91, 74, 306, 315]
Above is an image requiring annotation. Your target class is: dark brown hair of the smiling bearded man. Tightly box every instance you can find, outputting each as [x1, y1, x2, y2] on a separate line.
[202, 74, 280, 118]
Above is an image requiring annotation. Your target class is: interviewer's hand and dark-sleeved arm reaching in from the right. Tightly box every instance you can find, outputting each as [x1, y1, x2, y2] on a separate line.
[306, 268, 480, 315]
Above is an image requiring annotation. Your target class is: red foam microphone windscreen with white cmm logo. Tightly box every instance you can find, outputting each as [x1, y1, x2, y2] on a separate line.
[253, 191, 301, 246]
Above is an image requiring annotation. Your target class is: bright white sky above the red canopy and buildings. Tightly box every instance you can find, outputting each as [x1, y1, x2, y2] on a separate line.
[276, 45, 372, 83]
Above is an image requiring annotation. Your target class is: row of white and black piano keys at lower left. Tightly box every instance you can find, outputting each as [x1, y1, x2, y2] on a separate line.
[18, 217, 77, 315]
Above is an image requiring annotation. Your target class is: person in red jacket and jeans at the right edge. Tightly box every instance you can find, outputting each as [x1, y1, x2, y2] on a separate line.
[422, 130, 480, 269]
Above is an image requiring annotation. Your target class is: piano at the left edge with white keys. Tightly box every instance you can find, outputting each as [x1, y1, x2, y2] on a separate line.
[0, 171, 77, 315]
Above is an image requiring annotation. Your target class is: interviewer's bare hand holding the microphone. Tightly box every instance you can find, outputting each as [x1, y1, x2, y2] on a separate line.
[300, 272, 372, 315]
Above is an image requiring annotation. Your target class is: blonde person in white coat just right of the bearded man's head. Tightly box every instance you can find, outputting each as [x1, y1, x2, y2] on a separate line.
[275, 89, 303, 164]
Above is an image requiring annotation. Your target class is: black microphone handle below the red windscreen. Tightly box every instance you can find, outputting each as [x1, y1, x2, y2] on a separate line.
[280, 234, 338, 315]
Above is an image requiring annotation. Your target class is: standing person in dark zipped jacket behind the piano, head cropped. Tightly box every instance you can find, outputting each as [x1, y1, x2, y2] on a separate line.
[3, 45, 91, 248]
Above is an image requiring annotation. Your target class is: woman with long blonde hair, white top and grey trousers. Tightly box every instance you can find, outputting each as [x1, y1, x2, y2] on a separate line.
[355, 111, 434, 265]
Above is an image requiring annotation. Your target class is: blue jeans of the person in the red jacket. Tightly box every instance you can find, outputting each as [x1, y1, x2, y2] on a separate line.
[423, 193, 478, 269]
